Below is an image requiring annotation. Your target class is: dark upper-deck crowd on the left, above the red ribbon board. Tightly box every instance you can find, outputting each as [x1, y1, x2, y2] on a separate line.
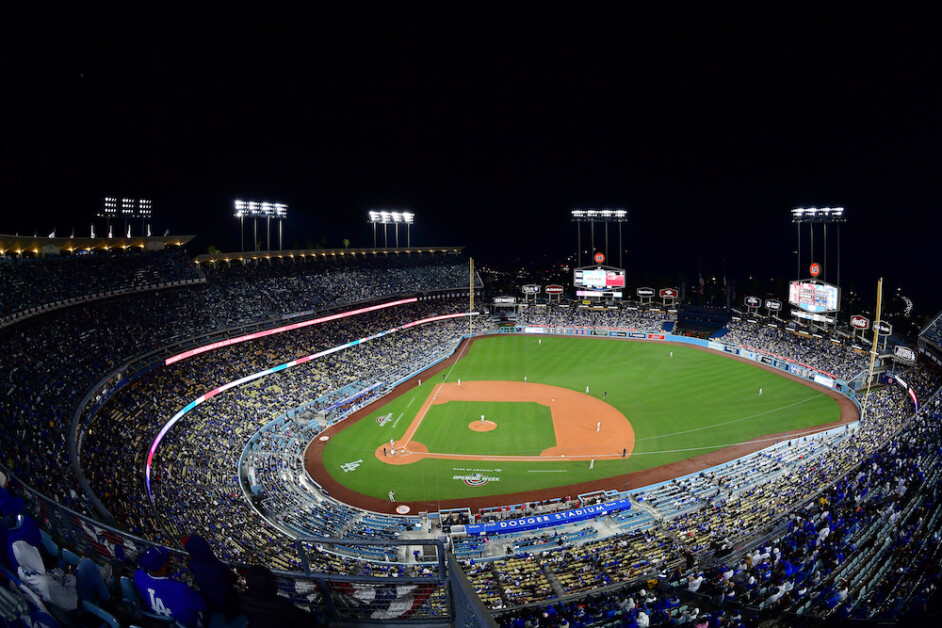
[0, 250, 476, 512]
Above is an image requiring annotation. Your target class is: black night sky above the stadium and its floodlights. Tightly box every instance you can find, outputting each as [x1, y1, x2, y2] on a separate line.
[0, 2, 942, 310]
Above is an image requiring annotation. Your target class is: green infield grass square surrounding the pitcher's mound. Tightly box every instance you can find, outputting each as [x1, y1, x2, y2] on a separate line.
[412, 401, 556, 456]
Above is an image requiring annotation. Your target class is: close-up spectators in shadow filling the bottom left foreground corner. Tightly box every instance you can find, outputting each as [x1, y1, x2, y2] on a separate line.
[0, 468, 326, 628]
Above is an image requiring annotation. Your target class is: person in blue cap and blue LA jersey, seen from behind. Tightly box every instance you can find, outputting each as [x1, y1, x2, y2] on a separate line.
[134, 547, 206, 628]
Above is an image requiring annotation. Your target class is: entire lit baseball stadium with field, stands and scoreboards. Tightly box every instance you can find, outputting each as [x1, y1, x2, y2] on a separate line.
[0, 235, 942, 628]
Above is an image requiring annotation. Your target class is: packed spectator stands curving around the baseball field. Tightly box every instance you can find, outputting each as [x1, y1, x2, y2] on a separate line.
[0, 249, 942, 626]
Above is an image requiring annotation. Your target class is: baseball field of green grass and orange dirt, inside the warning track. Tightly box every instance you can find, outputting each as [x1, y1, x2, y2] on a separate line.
[308, 335, 841, 505]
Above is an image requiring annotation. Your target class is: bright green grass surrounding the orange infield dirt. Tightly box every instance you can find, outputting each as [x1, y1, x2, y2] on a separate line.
[324, 336, 840, 501]
